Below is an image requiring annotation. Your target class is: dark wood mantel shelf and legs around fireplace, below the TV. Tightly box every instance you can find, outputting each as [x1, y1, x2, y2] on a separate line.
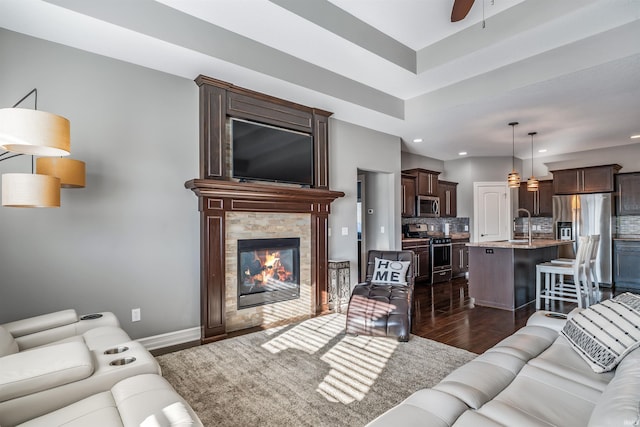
[185, 179, 344, 342]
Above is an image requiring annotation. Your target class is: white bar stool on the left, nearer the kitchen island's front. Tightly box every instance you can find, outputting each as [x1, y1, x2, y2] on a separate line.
[536, 236, 592, 310]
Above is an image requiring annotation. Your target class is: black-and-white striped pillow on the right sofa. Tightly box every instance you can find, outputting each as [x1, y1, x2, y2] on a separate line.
[562, 292, 640, 373]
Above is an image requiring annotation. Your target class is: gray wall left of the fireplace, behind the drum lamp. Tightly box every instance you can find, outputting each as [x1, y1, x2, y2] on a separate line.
[0, 29, 200, 338]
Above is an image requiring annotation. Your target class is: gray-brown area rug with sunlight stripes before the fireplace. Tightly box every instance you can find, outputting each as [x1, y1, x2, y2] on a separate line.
[157, 314, 476, 427]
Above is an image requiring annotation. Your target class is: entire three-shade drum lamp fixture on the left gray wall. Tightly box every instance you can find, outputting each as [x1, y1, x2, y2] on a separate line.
[0, 89, 85, 207]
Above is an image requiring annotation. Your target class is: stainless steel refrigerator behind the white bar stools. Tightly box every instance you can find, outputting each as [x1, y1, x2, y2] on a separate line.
[553, 193, 613, 285]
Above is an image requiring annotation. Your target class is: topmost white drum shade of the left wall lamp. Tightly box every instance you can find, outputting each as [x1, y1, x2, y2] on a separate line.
[0, 108, 71, 156]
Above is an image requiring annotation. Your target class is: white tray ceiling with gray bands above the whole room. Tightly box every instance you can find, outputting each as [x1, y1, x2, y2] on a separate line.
[0, 0, 640, 160]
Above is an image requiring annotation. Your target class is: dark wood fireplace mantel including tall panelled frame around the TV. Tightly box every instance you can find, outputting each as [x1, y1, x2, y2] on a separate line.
[185, 76, 344, 343]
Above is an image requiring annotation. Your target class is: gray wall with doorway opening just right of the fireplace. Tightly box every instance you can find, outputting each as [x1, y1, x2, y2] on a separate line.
[329, 119, 402, 286]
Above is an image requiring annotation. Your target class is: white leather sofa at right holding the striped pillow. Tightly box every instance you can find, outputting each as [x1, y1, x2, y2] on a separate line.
[368, 297, 640, 427]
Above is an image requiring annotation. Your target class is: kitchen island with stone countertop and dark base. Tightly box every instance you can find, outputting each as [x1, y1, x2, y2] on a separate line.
[467, 239, 572, 311]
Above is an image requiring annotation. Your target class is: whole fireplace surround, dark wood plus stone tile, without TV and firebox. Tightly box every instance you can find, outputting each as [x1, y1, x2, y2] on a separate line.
[185, 76, 344, 343]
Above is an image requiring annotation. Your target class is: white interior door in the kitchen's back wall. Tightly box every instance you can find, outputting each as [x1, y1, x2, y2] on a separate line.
[473, 182, 511, 242]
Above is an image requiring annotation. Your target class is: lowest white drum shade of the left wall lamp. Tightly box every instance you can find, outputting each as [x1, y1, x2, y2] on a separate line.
[2, 173, 60, 208]
